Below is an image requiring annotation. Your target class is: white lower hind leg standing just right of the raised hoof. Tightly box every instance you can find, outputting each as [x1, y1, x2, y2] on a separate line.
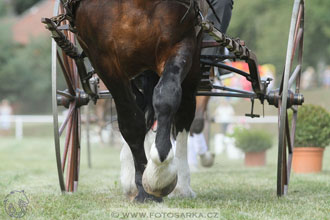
[170, 130, 196, 197]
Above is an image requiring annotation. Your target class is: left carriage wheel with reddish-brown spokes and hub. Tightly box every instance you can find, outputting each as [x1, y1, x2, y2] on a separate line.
[52, 1, 89, 192]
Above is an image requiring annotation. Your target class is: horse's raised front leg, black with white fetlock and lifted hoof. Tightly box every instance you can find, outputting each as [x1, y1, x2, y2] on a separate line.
[142, 37, 196, 197]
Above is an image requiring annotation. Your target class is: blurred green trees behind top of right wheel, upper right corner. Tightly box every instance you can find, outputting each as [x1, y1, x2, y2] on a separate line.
[228, 0, 330, 78]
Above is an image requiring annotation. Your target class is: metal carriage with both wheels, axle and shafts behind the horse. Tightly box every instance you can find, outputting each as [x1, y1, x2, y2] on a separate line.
[42, 0, 304, 196]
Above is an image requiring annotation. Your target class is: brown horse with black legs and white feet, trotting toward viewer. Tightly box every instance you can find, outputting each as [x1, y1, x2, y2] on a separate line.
[73, 0, 208, 202]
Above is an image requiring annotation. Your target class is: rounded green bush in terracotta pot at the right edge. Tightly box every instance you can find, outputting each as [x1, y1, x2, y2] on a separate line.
[290, 105, 330, 173]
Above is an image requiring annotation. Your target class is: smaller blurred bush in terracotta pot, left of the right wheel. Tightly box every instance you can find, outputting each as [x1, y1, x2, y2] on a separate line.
[233, 128, 273, 166]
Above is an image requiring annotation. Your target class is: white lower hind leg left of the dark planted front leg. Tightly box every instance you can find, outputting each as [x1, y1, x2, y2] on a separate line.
[120, 143, 138, 198]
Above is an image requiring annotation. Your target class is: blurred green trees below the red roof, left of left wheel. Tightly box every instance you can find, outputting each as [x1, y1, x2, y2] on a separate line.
[0, 22, 51, 113]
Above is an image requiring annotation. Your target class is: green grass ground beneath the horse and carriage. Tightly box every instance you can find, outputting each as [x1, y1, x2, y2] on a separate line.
[0, 138, 330, 219]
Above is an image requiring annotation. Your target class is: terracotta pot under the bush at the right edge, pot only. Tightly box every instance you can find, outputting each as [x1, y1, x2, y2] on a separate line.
[292, 147, 324, 173]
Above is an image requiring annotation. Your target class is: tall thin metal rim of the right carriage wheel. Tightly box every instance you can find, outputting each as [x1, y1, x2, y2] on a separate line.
[277, 0, 304, 196]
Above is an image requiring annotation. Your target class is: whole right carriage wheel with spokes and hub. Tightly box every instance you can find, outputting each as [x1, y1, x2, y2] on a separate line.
[277, 0, 304, 196]
